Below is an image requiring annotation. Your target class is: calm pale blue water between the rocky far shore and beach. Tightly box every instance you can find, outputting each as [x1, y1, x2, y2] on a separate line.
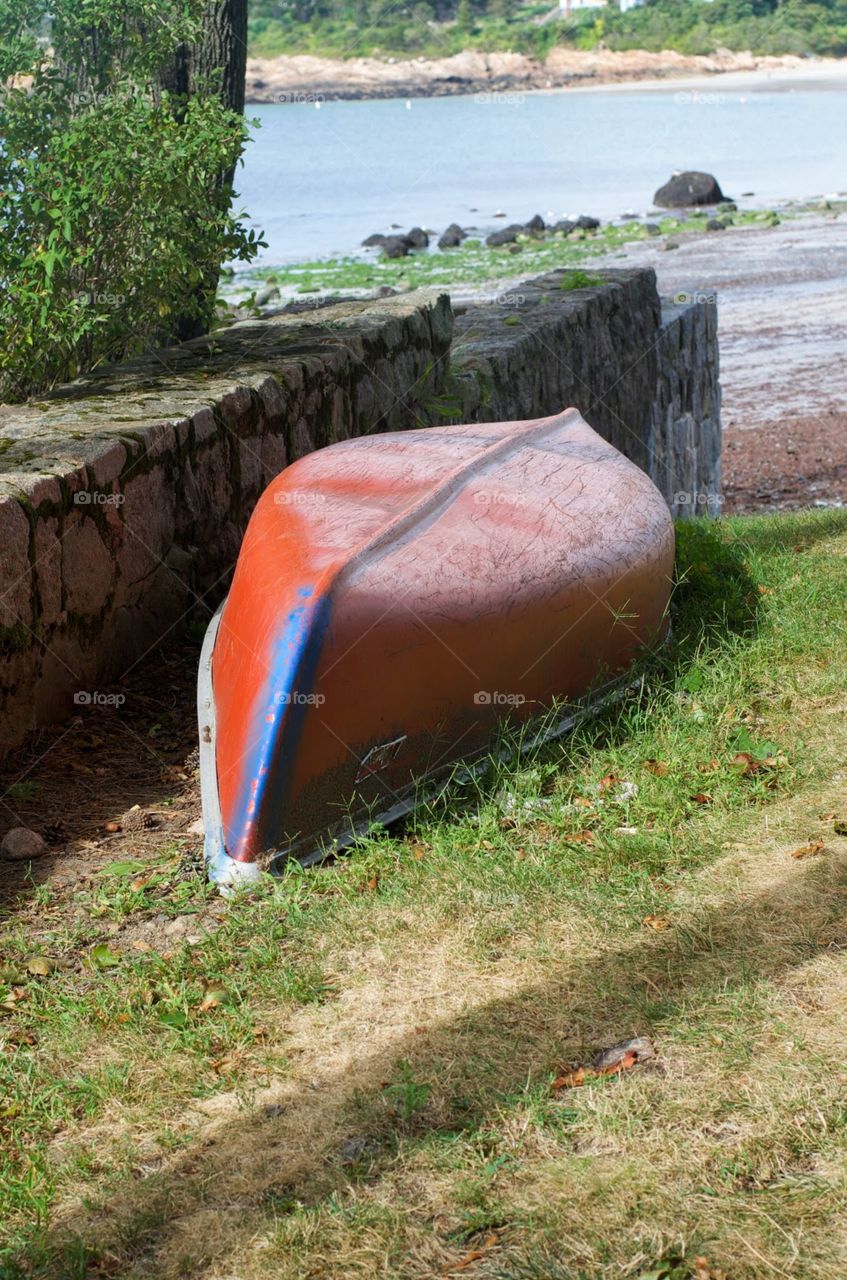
[237, 88, 847, 264]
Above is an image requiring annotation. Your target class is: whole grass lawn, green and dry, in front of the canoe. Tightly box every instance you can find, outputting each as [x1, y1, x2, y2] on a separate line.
[0, 511, 847, 1280]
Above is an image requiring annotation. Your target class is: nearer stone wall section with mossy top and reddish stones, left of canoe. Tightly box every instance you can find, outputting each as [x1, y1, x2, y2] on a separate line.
[0, 294, 453, 748]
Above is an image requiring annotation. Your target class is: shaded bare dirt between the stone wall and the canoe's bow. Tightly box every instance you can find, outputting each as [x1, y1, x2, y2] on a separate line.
[0, 643, 202, 909]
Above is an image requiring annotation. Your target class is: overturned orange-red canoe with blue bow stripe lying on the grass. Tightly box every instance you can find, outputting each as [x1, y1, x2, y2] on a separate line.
[198, 410, 673, 883]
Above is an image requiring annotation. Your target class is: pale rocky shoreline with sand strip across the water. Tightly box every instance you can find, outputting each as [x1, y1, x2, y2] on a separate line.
[247, 47, 846, 104]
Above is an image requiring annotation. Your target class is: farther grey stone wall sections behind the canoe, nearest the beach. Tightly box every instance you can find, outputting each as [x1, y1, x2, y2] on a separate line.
[444, 269, 720, 515]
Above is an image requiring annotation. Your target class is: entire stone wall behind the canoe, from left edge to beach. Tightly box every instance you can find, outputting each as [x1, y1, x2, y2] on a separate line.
[0, 270, 720, 750]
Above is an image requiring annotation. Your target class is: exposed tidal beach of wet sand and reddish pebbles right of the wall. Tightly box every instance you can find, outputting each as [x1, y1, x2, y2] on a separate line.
[606, 212, 847, 512]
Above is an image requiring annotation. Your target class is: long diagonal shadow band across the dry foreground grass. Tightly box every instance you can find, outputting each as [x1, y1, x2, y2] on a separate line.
[11, 834, 847, 1280]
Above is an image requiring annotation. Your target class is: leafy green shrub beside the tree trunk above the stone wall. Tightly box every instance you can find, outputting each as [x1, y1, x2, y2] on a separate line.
[0, 0, 266, 401]
